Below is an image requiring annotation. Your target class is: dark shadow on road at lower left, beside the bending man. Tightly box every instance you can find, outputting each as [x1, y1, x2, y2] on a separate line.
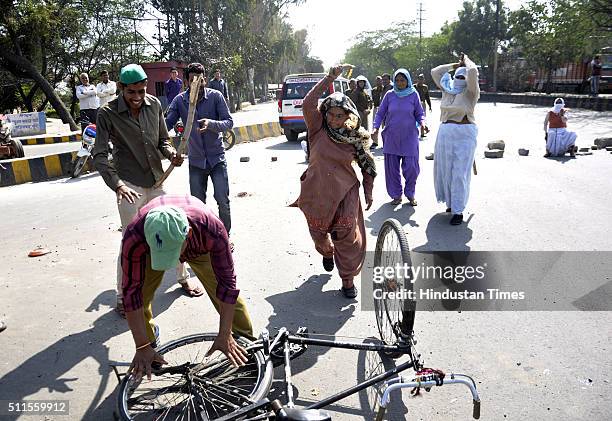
[0, 277, 181, 419]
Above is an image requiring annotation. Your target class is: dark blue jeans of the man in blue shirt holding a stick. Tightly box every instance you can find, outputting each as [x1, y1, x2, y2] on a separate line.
[189, 161, 232, 234]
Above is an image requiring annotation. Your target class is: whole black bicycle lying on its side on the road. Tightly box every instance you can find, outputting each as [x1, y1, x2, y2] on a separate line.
[113, 219, 480, 421]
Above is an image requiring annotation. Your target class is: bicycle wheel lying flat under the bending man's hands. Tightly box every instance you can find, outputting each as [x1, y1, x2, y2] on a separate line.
[117, 333, 272, 420]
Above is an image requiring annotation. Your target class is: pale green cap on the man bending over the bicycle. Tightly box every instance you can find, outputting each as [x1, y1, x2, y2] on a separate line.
[144, 206, 189, 270]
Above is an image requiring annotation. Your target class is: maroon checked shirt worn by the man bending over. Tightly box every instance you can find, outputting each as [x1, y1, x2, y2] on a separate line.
[121, 195, 240, 311]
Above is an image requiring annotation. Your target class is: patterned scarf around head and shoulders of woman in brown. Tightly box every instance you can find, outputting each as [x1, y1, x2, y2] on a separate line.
[319, 92, 376, 177]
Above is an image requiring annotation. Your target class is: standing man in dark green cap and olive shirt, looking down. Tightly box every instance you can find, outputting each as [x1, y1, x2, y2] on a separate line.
[93, 64, 204, 316]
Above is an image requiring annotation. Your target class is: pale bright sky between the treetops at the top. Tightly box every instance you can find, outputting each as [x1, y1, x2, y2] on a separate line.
[287, 0, 526, 67]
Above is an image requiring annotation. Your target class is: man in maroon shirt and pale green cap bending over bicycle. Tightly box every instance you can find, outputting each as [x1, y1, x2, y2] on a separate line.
[121, 195, 253, 379]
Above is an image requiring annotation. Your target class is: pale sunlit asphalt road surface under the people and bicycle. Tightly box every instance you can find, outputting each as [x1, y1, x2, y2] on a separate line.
[0, 102, 612, 420]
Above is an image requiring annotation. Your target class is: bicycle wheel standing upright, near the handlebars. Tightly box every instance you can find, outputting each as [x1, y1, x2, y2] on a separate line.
[373, 219, 416, 345]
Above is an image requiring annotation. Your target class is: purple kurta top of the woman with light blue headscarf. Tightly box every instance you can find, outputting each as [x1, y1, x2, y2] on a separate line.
[374, 91, 425, 156]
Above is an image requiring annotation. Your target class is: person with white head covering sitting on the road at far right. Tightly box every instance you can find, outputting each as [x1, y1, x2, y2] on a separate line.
[544, 98, 578, 158]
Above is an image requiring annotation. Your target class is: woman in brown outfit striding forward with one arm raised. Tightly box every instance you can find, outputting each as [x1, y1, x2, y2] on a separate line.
[291, 66, 376, 298]
